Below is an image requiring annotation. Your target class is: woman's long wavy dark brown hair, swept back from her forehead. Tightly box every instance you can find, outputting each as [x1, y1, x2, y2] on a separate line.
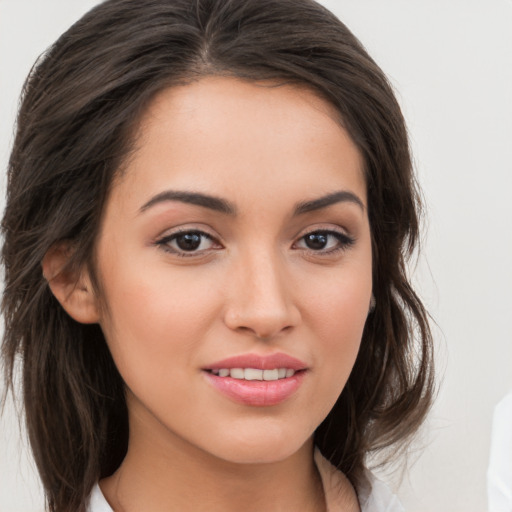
[2, 0, 433, 512]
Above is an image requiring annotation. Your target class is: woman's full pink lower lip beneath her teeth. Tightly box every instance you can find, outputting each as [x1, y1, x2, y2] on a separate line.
[204, 371, 306, 407]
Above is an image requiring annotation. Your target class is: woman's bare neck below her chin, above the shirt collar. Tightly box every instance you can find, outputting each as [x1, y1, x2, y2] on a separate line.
[100, 410, 325, 512]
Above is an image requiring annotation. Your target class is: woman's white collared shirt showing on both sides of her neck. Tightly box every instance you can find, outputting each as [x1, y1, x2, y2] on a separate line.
[87, 450, 404, 512]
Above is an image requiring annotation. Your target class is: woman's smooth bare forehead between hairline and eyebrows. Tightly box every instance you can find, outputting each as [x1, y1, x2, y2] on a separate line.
[110, 77, 366, 213]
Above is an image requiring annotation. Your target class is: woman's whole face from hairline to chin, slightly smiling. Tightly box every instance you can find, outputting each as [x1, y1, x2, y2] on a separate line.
[93, 78, 372, 462]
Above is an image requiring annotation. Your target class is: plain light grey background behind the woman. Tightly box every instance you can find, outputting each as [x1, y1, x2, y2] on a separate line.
[0, 0, 512, 512]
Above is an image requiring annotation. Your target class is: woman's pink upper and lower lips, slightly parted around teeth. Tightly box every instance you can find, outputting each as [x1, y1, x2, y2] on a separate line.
[203, 353, 307, 407]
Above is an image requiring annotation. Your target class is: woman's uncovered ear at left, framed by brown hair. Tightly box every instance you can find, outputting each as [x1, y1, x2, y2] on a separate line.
[41, 242, 99, 324]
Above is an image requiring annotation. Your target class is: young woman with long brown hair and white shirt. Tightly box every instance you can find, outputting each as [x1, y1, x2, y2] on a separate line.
[2, 0, 432, 512]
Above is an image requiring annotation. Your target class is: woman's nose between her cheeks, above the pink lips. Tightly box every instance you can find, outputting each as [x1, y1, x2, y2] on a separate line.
[224, 251, 301, 339]
